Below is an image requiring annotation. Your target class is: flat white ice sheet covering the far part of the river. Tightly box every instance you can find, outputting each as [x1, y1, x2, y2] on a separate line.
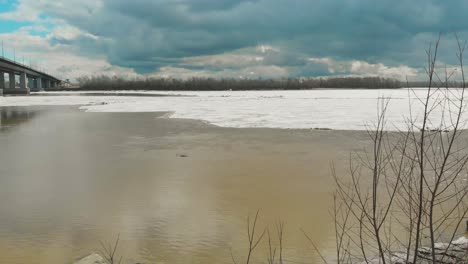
[0, 89, 468, 130]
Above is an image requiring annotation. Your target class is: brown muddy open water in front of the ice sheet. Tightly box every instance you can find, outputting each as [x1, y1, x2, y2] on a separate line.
[0, 107, 369, 263]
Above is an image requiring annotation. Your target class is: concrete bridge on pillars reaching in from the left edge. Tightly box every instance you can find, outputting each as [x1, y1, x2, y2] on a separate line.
[0, 57, 61, 95]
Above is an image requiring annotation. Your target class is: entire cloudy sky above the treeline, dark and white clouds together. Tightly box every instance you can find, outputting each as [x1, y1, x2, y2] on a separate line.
[0, 0, 468, 80]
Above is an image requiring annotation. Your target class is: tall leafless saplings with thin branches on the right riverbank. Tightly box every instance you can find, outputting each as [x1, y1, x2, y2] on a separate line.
[332, 35, 468, 264]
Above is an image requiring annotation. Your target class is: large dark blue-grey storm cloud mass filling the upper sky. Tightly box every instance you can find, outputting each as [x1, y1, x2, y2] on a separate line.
[36, 0, 468, 72]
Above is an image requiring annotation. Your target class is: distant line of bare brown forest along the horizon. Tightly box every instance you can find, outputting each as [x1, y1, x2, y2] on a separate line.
[78, 76, 459, 91]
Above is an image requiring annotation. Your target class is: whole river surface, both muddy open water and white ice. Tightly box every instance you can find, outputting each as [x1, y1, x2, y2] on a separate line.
[0, 89, 463, 264]
